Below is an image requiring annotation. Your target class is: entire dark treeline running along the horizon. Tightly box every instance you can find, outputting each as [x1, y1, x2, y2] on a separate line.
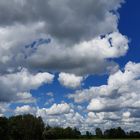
[0, 115, 140, 140]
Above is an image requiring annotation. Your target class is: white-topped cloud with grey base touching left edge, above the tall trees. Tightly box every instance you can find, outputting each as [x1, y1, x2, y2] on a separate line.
[0, 68, 54, 102]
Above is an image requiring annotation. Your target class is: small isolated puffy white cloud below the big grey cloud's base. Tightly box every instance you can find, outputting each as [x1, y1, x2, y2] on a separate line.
[58, 72, 83, 89]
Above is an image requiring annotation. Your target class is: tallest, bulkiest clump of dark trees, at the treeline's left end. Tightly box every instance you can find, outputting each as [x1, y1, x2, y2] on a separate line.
[0, 115, 45, 140]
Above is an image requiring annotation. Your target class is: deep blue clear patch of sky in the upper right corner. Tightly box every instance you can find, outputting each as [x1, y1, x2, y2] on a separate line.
[118, 0, 140, 65]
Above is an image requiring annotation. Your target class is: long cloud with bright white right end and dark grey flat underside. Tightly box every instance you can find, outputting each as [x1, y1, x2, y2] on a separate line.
[27, 32, 128, 75]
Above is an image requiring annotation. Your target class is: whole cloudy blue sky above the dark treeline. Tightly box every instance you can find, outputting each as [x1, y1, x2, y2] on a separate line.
[0, 0, 140, 133]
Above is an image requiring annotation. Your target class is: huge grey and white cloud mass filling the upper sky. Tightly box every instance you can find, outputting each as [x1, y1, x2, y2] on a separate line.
[0, 0, 128, 75]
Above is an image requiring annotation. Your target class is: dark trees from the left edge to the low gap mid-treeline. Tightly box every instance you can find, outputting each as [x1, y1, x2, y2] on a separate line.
[0, 114, 81, 140]
